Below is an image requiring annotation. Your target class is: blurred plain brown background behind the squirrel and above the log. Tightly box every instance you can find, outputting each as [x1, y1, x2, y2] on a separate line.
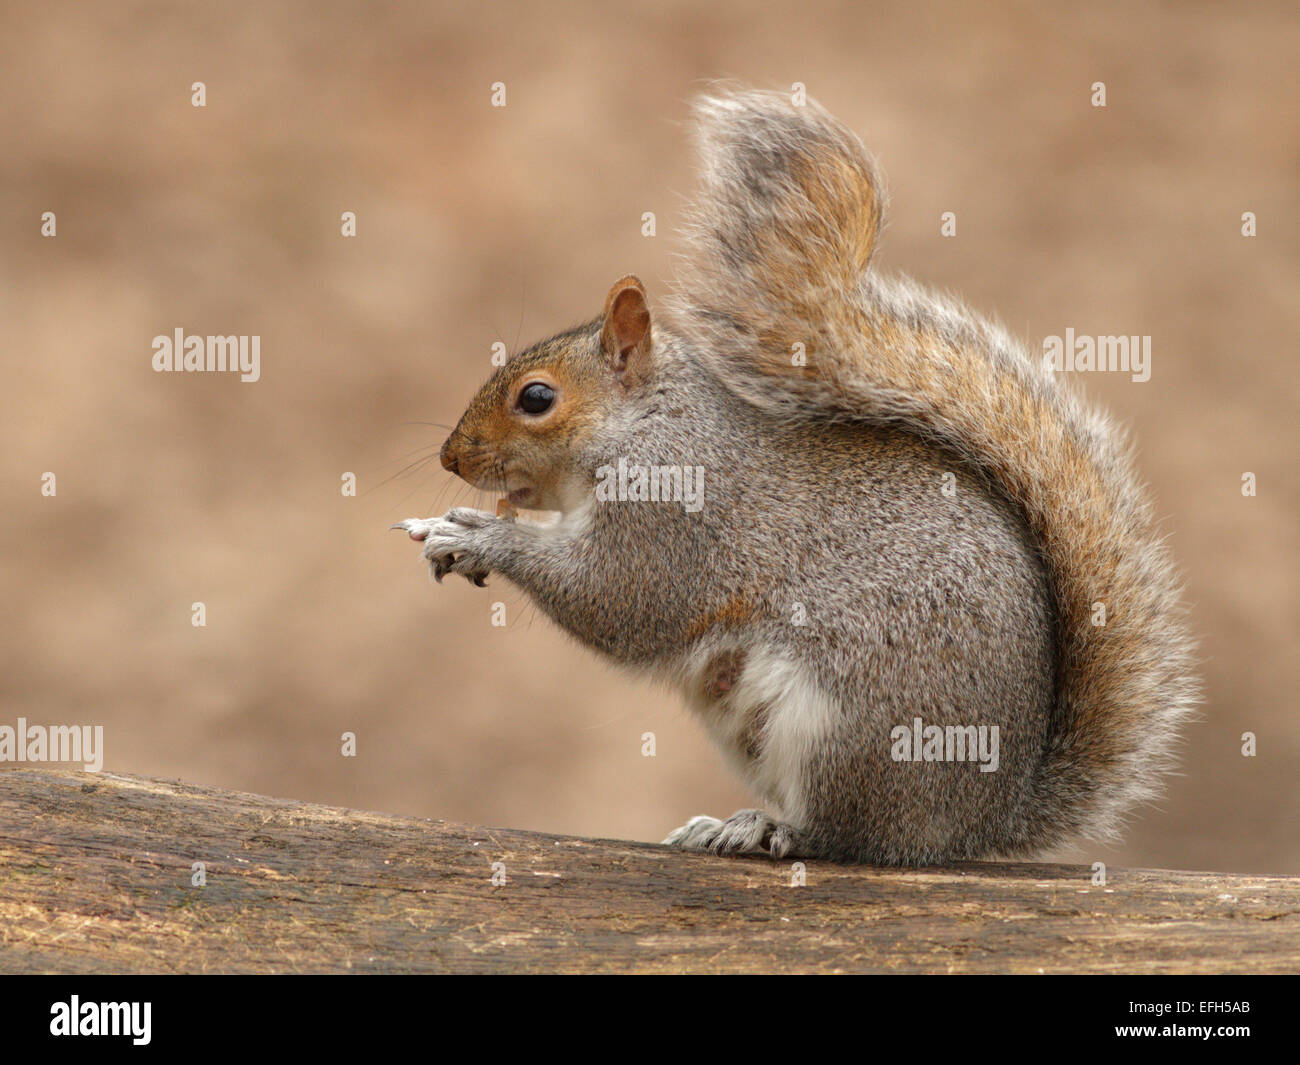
[0, 1, 1300, 873]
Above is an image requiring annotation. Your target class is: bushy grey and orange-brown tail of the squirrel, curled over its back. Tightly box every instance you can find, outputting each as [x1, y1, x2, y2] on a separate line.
[668, 90, 1199, 850]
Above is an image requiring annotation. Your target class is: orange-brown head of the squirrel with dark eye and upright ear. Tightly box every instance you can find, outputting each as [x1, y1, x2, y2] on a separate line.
[442, 276, 653, 511]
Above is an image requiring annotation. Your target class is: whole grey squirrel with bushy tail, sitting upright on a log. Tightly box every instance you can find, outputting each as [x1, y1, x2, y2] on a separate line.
[394, 88, 1199, 865]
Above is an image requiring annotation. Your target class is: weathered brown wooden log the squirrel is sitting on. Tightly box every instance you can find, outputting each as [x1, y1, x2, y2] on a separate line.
[0, 767, 1300, 973]
